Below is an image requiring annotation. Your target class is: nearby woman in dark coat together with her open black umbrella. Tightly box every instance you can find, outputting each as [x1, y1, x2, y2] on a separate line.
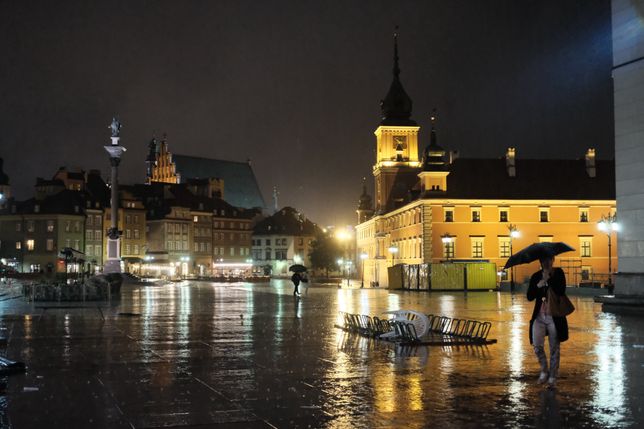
[505, 243, 574, 388]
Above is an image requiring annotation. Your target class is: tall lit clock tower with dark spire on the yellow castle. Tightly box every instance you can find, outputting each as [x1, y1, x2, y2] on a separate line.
[373, 29, 421, 214]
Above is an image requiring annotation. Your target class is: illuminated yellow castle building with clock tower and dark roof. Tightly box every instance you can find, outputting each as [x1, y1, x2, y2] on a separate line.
[356, 34, 617, 286]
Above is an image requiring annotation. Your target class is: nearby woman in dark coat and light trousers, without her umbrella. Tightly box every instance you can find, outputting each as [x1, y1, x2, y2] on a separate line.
[528, 256, 568, 388]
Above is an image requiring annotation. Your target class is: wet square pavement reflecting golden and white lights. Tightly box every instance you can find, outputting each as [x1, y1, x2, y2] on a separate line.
[0, 281, 644, 428]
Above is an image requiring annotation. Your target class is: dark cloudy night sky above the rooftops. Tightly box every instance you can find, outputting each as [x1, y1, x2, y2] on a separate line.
[0, 0, 614, 224]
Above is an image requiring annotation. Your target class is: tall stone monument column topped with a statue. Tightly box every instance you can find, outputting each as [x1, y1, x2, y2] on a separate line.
[103, 118, 126, 274]
